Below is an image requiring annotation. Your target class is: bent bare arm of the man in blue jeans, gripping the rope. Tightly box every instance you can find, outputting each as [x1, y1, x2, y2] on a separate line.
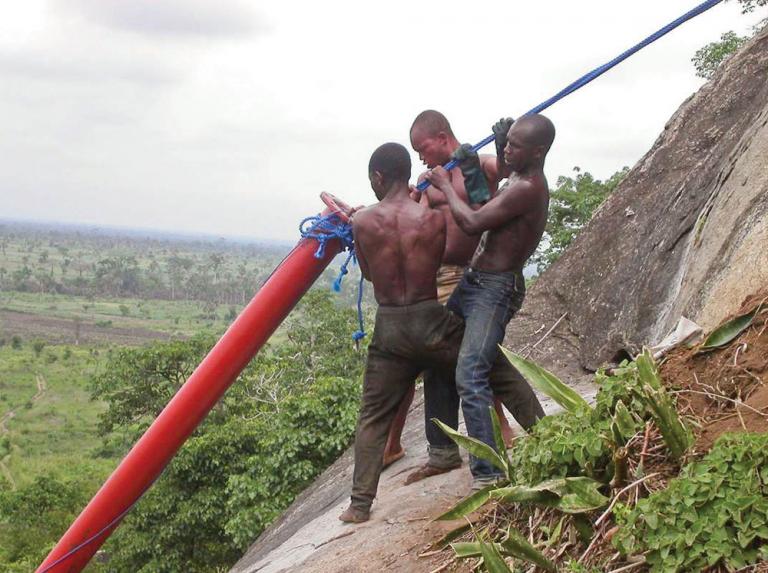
[427, 167, 539, 235]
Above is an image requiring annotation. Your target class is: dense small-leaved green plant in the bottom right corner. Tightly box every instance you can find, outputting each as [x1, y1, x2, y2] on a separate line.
[613, 434, 768, 572]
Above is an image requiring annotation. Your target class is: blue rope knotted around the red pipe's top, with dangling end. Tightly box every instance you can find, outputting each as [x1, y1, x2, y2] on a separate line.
[299, 213, 366, 345]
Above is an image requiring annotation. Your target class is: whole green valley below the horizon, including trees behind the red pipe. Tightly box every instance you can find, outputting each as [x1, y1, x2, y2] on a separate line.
[0, 220, 370, 572]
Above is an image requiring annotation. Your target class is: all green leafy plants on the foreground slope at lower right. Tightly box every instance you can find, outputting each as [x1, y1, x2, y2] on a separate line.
[426, 351, 768, 573]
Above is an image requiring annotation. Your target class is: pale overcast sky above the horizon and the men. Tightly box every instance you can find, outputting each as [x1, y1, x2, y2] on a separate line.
[0, 0, 766, 240]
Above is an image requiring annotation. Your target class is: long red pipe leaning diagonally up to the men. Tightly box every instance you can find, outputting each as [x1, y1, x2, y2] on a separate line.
[37, 197, 343, 573]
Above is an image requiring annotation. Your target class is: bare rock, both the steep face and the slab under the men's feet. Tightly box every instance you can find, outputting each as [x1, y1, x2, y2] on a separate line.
[233, 28, 768, 573]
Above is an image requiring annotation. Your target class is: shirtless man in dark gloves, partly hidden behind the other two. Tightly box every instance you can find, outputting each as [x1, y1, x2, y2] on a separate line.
[384, 109, 514, 470]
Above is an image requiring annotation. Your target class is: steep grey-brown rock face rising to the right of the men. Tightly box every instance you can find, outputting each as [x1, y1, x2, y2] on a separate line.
[508, 23, 768, 370]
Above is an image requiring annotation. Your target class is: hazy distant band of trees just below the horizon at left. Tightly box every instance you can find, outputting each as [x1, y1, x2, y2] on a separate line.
[0, 225, 371, 306]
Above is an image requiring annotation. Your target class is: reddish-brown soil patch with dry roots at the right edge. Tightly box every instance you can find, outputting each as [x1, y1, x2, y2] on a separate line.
[660, 290, 768, 453]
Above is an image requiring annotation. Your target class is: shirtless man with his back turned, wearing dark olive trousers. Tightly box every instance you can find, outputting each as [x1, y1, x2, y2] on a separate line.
[339, 143, 538, 523]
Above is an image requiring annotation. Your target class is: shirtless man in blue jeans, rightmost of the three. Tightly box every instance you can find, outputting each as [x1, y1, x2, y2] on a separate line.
[426, 114, 555, 485]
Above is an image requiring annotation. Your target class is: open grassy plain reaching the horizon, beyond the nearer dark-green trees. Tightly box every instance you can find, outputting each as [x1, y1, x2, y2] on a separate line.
[0, 221, 370, 494]
